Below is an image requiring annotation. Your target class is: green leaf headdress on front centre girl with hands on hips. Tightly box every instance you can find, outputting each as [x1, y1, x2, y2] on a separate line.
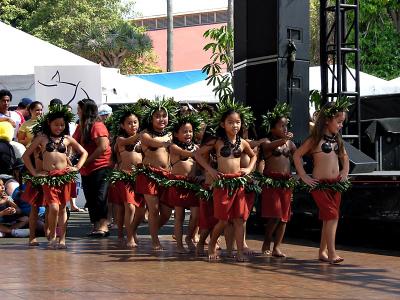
[211, 99, 255, 129]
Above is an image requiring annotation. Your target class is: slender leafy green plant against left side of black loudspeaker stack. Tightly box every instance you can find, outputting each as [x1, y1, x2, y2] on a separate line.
[202, 26, 233, 101]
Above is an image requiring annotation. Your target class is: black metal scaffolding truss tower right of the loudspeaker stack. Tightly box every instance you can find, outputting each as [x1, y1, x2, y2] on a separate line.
[320, 0, 361, 148]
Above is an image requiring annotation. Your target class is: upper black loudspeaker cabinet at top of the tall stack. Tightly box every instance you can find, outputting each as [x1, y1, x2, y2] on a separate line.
[234, 0, 310, 64]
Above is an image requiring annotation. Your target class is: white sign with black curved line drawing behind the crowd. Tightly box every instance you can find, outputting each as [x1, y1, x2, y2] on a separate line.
[35, 65, 102, 112]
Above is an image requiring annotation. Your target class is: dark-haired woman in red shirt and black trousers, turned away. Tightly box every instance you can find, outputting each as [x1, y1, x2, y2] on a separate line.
[73, 99, 111, 237]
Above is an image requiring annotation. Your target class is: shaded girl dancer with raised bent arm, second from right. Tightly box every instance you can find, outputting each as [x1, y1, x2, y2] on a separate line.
[260, 103, 296, 257]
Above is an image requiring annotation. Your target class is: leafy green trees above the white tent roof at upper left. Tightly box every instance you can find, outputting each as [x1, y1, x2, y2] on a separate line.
[0, 0, 152, 67]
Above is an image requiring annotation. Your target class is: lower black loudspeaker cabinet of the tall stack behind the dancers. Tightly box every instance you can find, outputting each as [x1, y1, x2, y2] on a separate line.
[234, 58, 309, 141]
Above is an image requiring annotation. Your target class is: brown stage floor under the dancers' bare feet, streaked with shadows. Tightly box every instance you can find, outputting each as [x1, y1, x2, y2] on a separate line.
[0, 213, 400, 300]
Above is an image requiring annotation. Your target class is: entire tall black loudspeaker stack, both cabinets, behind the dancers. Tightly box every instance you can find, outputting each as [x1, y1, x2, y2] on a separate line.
[234, 0, 310, 142]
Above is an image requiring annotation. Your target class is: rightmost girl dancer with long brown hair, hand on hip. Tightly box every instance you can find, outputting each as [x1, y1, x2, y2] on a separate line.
[293, 98, 349, 264]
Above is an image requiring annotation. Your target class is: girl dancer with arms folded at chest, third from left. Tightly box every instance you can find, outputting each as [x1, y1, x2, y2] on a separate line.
[135, 99, 177, 251]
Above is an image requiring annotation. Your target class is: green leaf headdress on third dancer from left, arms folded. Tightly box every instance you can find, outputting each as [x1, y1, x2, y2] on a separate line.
[143, 97, 179, 128]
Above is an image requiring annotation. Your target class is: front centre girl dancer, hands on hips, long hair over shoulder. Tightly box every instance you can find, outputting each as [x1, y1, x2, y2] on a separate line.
[195, 100, 257, 261]
